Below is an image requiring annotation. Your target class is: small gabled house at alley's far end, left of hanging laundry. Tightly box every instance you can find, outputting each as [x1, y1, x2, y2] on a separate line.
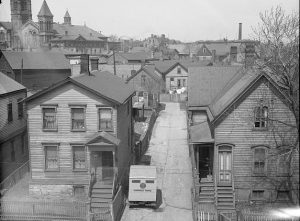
[127, 64, 164, 107]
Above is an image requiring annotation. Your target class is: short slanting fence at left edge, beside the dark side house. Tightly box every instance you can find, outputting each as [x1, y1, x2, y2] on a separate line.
[0, 161, 29, 192]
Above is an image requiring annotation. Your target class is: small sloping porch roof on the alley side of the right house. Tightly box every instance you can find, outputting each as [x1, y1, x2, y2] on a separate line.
[190, 121, 214, 144]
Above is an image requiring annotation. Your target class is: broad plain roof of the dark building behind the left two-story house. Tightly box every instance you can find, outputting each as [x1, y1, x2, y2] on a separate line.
[3, 51, 71, 70]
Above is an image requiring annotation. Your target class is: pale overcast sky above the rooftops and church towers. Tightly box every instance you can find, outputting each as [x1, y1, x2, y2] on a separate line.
[0, 0, 299, 42]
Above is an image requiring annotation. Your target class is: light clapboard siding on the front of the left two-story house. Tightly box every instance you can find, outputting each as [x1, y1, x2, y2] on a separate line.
[28, 83, 122, 183]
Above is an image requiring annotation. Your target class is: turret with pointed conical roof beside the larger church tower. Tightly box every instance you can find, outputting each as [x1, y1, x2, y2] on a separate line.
[38, 0, 53, 45]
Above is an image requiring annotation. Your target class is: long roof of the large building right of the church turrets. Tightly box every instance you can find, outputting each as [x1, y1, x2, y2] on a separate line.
[53, 23, 106, 40]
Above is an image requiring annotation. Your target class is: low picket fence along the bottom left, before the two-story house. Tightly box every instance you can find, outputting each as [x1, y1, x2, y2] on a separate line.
[0, 200, 88, 220]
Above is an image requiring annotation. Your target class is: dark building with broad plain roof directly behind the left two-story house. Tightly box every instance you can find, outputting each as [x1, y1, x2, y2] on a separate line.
[0, 51, 71, 91]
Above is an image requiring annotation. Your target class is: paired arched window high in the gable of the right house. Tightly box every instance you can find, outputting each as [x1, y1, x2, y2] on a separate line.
[253, 105, 270, 130]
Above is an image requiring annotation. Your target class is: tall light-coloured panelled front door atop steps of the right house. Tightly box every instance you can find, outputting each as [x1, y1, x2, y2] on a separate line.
[219, 147, 232, 185]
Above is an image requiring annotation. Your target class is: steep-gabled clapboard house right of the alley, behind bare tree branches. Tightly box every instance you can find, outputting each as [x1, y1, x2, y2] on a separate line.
[188, 67, 299, 218]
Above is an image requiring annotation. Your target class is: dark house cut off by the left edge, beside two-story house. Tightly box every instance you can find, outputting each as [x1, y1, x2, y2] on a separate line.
[0, 72, 28, 181]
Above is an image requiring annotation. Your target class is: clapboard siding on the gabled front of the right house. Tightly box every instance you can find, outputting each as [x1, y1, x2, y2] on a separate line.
[215, 82, 299, 200]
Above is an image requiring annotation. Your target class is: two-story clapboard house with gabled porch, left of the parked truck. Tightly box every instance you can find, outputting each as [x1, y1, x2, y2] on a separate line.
[26, 71, 134, 212]
